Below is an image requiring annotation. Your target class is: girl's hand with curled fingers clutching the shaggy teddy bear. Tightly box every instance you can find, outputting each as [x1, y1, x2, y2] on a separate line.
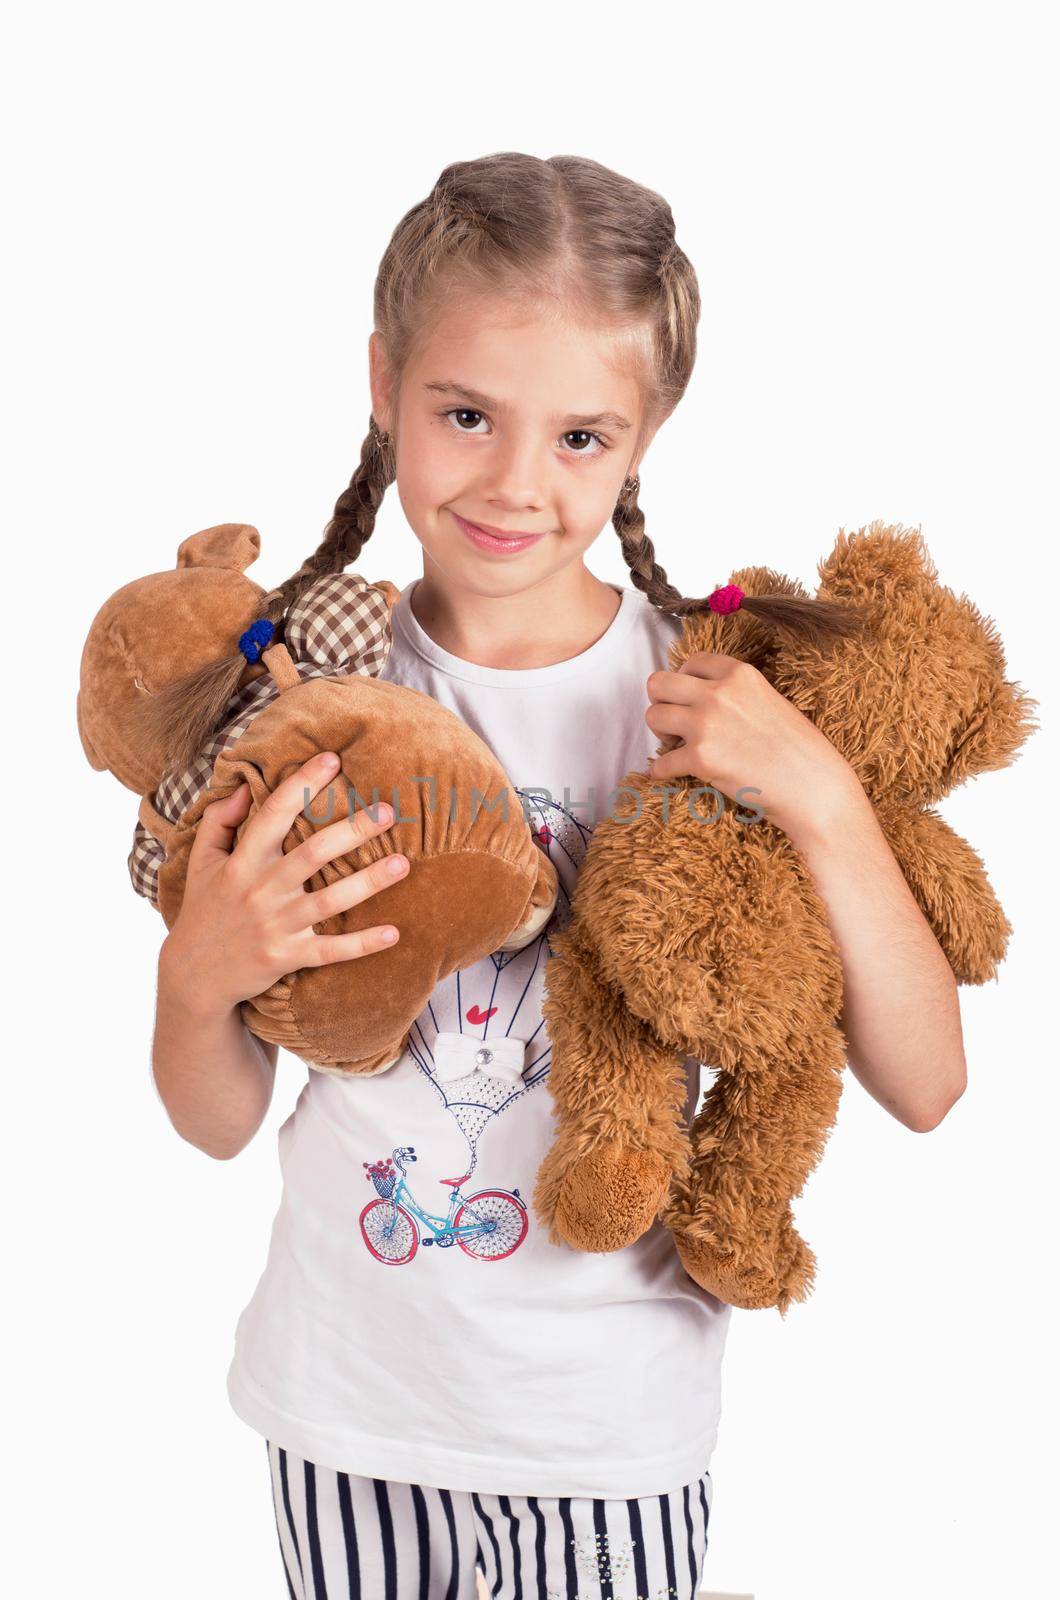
[644, 650, 865, 837]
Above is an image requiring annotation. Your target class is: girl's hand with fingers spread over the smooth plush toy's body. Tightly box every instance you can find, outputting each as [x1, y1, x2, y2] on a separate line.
[165, 752, 408, 1011]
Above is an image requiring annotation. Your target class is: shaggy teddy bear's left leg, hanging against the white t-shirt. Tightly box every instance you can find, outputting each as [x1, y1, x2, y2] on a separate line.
[533, 941, 689, 1251]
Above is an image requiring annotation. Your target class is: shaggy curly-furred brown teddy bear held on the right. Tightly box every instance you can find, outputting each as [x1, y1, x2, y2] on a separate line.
[533, 523, 1036, 1317]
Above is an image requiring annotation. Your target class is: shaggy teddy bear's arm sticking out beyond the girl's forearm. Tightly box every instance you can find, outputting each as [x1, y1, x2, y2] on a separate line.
[881, 808, 1012, 984]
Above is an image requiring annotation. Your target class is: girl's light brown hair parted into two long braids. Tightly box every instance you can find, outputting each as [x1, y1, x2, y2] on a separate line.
[141, 150, 857, 765]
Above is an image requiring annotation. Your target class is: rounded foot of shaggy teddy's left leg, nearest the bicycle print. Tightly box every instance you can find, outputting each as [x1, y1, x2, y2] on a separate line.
[552, 1144, 671, 1251]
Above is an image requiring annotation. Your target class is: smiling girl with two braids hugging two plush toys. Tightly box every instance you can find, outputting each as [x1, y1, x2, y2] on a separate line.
[154, 154, 964, 1600]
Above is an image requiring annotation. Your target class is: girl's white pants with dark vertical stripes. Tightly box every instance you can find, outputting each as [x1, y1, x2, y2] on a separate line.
[267, 1440, 713, 1600]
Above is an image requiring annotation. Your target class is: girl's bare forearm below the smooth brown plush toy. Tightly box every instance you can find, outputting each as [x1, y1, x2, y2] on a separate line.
[152, 939, 277, 1160]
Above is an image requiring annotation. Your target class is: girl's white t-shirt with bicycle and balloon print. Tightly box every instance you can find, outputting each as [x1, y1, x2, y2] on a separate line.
[227, 579, 732, 1499]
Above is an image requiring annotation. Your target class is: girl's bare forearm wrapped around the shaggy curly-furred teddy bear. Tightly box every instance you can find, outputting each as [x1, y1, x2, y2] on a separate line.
[786, 773, 967, 1133]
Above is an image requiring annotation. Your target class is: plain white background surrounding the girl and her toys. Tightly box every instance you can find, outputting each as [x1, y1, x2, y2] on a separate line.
[0, 0, 1060, 1600]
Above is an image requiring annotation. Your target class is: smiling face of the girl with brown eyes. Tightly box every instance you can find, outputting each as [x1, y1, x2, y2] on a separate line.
[370, 299, 644, 595]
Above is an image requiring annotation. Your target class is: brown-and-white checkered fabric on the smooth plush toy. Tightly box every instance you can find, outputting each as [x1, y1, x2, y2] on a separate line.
[128, 573, 391, 909]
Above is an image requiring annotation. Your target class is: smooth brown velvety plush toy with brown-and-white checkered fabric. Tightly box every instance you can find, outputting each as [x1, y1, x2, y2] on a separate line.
[77, 523, 557, 1075]
